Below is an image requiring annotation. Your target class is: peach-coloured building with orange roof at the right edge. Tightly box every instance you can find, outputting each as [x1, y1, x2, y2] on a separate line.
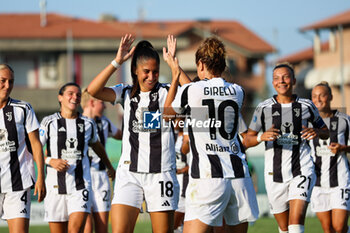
[279, 10, 350, 114]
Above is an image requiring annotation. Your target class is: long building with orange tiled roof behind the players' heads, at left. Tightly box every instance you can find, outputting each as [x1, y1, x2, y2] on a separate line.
[0, 13, 275, 122]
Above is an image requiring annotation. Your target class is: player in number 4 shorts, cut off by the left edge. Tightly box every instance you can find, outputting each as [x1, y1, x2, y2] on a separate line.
[0, 64, 46, 233]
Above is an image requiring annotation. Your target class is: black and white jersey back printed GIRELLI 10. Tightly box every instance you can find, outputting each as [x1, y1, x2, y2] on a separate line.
[172, 78, 249, 179]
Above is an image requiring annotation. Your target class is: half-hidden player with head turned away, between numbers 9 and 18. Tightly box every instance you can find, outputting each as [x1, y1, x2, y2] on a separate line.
[81, 89, 122, 233]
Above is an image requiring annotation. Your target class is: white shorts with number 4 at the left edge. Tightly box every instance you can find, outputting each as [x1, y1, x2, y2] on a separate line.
[0, 188, 31, 219]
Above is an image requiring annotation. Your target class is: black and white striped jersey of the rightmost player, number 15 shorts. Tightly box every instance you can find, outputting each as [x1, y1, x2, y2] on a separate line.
[311, 111, 350, 188]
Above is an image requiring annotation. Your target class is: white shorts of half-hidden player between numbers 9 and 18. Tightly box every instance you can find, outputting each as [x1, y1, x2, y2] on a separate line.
[91, 170, 111, 212]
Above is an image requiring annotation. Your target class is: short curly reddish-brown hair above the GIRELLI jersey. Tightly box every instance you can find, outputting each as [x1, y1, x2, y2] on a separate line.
[196, 37, 226, 75]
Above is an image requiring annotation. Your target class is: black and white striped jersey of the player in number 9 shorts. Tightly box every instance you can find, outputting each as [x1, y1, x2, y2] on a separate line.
[40, 112, 98, 194]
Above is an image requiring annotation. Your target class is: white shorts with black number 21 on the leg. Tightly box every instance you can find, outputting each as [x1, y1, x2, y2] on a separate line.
[265, 173, 316, 214]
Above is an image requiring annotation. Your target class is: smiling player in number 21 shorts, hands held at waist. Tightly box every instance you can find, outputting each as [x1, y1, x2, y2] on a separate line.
[244, 63, 328, 233]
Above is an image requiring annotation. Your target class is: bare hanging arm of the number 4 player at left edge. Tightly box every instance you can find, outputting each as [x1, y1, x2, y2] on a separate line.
[28, 130, 46, 202]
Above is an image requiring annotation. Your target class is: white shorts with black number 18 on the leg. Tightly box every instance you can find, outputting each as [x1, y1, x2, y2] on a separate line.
[112, 167, 179, 212]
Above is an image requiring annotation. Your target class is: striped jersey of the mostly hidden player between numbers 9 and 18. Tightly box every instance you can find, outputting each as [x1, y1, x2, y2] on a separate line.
[88, 116, 118, 171]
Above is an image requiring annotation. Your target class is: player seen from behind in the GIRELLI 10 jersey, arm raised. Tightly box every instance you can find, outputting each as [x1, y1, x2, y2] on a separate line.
[164, 37, 258, 233]
